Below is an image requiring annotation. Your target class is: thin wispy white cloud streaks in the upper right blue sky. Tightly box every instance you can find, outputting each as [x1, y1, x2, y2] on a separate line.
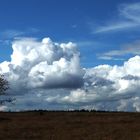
[93, 2, 140, 33]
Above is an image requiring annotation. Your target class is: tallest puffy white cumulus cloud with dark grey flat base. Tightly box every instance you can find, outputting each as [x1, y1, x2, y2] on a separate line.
[0, 38, 84, 93]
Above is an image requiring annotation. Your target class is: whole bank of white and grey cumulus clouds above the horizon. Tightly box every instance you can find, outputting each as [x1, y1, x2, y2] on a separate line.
[0, 38, 140, 111]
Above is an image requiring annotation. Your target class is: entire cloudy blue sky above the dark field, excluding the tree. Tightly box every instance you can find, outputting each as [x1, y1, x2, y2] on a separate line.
[0, 0, 140, 111]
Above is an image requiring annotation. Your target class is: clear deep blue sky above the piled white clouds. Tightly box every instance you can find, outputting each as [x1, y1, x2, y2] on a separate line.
[0, 0, 140, 67]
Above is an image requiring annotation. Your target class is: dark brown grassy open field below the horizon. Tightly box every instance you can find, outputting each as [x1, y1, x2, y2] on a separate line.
[0, 112, 140, 140]
